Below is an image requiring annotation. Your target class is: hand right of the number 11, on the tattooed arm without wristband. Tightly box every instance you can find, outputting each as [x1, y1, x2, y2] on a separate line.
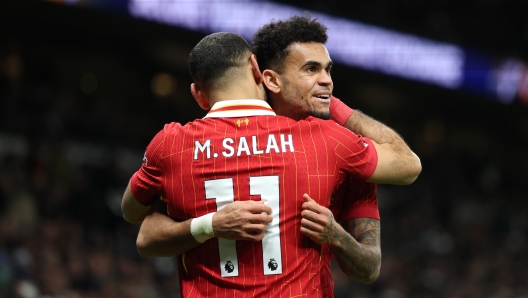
[301, 194, 344, 244]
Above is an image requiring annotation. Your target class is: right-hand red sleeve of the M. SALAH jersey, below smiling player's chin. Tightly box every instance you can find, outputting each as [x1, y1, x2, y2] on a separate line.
[320, 121, 378, 181]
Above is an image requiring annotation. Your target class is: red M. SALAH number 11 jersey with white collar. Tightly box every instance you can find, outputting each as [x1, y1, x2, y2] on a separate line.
[131, 100, 377, 297]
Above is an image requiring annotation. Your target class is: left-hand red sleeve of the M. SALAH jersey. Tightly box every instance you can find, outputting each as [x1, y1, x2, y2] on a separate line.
[130, 123, 181, 206]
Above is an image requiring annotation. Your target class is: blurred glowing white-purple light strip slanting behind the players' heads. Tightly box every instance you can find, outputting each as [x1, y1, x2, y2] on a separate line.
[49, 0, 528, 104]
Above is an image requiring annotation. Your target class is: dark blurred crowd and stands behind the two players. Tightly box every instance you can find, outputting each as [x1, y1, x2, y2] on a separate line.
[0, 0, 528, 298]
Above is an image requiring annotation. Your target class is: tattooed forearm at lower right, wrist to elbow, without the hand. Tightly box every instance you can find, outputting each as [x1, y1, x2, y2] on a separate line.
[331, 218, 381, 284]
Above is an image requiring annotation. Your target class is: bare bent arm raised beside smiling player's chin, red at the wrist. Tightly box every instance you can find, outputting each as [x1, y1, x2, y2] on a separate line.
[330, 97, 422, 185]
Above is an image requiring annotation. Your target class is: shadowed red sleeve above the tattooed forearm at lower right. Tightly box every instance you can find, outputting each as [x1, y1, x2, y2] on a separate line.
[339, 179, 380, 223]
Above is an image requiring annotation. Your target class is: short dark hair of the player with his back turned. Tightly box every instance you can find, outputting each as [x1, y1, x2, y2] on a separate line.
[189, 32, 252, 89]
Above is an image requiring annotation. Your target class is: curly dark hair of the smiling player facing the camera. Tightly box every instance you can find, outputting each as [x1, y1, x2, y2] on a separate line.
[251, 13, 328, 72]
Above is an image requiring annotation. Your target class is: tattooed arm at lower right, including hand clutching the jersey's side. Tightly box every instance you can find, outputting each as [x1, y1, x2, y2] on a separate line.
[301, 194, 381, 284]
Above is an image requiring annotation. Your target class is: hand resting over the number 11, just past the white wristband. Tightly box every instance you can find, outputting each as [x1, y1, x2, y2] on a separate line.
[213, 200, 272, 241]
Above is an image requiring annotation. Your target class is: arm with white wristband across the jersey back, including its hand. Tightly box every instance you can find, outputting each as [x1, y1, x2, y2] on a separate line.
[136, 201, 272, 257]
